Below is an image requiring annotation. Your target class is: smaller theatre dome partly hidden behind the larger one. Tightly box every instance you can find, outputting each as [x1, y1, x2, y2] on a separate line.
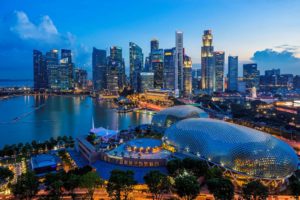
[152, 105, 208, 133]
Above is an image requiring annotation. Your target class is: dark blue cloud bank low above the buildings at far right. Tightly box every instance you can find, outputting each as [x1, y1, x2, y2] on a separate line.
[251, 45, 300, 74]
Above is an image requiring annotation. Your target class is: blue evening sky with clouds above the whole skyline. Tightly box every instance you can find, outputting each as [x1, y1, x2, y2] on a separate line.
[0, 0, 300, 78]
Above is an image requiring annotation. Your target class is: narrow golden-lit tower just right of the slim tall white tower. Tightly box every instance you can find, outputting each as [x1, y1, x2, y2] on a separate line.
[183, 55, 192, 97]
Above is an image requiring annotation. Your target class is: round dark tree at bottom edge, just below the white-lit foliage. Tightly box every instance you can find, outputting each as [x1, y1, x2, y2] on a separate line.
[175, 172, 200, 200]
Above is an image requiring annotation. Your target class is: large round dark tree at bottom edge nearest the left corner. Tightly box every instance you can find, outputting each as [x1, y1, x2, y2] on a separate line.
[12, 172, 39, 200]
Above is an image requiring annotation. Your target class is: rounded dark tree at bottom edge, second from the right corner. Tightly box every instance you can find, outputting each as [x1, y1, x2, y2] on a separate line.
[242, 181, 269, 200]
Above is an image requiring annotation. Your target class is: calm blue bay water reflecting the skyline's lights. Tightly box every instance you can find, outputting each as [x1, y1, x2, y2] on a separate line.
[0, 96, 152, 147]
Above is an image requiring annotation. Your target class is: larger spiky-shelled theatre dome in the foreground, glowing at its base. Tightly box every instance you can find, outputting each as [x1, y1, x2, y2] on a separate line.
[163, 118, 298, 180]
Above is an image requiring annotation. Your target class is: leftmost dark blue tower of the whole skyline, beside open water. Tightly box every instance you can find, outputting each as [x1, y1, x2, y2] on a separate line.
[33, 50, 48, 90]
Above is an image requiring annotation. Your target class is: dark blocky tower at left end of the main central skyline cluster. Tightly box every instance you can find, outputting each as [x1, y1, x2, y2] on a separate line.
[92, 47, 107, 90]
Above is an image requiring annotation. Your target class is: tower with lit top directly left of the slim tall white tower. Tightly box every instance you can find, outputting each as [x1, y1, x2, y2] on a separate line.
[163, 48, 178, 91]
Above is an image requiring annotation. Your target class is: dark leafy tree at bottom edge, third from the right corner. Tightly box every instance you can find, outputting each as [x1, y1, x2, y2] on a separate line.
[207, 178, 234, 200]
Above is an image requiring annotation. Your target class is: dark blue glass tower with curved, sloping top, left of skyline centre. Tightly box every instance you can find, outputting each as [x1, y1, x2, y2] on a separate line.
[129, 42, 144, 92]
